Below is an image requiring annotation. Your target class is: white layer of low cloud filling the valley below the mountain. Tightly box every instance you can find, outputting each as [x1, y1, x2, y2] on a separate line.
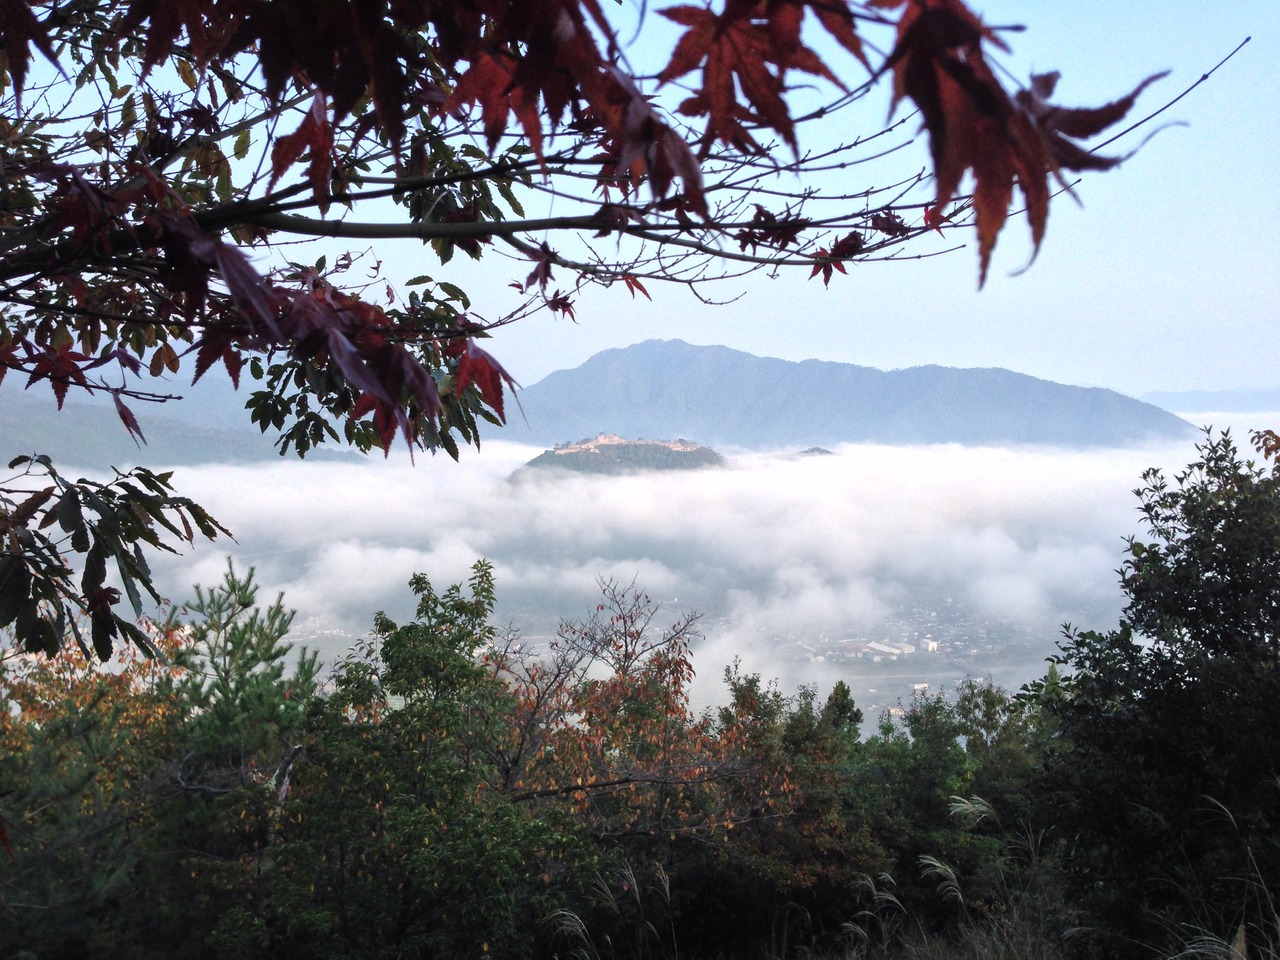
[149, 443, 1194, 701]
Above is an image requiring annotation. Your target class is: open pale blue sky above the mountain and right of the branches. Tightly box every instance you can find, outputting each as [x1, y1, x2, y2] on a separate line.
[437, 0, 1280, 394]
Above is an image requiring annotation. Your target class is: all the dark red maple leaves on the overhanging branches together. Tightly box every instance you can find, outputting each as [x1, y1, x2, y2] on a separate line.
[0, 0, 1172, 445]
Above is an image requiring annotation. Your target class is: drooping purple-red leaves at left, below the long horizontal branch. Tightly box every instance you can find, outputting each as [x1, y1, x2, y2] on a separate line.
[0, 156, 513, 449]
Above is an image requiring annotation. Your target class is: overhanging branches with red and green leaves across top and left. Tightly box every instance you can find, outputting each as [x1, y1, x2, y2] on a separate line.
[0, 0, 1177, 652]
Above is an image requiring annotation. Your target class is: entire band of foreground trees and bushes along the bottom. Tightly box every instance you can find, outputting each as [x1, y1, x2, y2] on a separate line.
[0, 436, 1280, 960]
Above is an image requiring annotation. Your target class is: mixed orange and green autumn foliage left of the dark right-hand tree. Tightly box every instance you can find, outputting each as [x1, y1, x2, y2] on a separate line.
[0, 563, 1013, 957]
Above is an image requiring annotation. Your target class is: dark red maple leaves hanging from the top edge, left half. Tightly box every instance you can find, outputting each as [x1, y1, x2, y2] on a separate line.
[0, 0, 705, 211]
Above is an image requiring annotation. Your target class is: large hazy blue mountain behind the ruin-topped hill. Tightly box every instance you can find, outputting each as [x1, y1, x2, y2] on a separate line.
[504, 340, 1196, 448]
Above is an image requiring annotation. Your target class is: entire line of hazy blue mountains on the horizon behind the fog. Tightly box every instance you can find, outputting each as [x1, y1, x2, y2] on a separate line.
[0, 340, 1213, 466]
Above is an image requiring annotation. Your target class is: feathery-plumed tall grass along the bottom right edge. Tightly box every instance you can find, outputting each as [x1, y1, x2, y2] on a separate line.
[547, 797, 1280, 960]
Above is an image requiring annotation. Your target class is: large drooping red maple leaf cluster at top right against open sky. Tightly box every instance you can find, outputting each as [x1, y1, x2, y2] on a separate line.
[873, 0, 1165, 285]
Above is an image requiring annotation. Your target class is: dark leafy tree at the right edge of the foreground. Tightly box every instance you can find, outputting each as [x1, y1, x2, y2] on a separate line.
[1041, 433, 1280, 954]
